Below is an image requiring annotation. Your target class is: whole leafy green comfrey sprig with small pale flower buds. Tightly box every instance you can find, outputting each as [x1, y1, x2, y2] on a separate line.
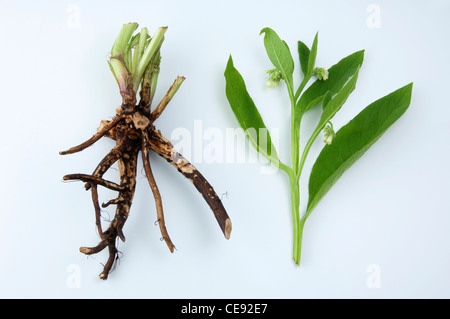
[225, 28, 412, 265]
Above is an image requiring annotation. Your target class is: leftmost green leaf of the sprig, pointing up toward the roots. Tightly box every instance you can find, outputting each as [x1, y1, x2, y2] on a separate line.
[225, 55, 279, 163]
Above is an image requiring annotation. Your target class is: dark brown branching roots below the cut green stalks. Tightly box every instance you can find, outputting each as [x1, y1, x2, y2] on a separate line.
[60, 101, 231, 280]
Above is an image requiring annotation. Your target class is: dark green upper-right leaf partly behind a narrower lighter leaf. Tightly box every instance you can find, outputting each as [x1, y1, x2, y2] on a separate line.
[295, 50, 364, 118]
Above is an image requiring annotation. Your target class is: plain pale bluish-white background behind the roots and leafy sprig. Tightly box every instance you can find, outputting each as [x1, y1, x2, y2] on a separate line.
[0, 0, 450, 298]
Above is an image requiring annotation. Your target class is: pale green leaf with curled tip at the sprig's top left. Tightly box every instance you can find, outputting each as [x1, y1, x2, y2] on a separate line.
[260, 28, 294, 91]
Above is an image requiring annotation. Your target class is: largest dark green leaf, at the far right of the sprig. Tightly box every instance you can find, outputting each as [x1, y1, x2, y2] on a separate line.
[304, 83, 412, 219]
